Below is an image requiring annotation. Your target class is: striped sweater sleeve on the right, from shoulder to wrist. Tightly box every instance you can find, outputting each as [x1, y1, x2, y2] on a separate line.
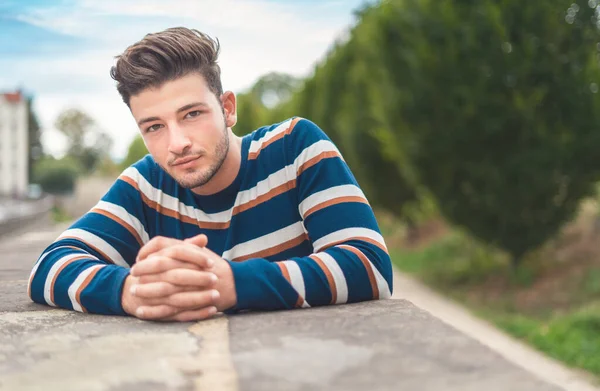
[230, 118, 392, 310]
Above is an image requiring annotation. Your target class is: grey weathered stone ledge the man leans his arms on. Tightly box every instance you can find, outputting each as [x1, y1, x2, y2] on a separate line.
[0, 224, 580, 391]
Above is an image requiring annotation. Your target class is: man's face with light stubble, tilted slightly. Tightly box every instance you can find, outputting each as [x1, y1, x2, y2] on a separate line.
[129, 73, 235, 189]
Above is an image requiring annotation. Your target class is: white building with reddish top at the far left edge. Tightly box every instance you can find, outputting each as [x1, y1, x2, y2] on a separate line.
[0, 91, 29, 197]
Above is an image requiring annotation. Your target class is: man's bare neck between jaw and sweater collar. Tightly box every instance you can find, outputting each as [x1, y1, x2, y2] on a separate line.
[192, 129, 242, 195]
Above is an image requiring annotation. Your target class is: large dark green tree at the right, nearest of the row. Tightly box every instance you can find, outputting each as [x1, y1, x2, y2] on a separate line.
[373, 0, 600, 264]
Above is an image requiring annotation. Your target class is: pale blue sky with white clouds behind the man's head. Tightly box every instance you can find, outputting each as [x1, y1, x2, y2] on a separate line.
[0, 0, 367, 160]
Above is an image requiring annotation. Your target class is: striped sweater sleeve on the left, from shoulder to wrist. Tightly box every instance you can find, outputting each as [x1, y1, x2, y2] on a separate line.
[28, 160, 154, 315]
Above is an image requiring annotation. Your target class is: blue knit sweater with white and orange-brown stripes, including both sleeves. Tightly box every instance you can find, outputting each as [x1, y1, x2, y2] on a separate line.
[28, 117, 392, 315]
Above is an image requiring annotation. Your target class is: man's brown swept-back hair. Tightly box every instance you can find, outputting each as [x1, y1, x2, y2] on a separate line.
[110, 27, 223, 106]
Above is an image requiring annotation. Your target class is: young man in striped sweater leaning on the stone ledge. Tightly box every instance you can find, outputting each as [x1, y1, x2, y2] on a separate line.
[28, 28, 392, 321]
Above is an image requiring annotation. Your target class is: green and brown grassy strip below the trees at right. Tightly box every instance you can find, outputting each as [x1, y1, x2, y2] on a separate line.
[390, 224, 600, 376]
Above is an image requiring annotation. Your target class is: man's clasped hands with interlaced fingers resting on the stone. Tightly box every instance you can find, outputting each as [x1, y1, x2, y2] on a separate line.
[121, 235, 237, 322]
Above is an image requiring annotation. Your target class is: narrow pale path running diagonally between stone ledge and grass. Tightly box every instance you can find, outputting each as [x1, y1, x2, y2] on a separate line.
[393, 271, 600, 391]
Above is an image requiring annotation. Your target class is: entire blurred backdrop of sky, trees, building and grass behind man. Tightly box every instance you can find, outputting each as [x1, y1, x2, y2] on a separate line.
[0, 0, 600, 382]
